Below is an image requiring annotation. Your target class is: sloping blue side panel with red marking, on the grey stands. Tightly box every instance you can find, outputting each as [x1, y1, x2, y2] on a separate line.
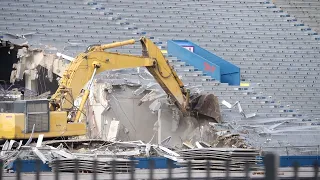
[167, 41, 221, 81]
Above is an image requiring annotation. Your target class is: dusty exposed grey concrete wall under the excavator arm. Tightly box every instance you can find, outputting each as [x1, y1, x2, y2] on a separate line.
[95, 86, 198, 145]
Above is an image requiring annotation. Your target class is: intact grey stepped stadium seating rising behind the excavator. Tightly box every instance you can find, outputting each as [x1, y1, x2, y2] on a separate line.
[0, 0, 320, 154]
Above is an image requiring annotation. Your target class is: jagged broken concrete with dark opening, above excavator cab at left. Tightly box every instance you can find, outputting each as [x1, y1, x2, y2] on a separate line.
[0, 40, 73, 100]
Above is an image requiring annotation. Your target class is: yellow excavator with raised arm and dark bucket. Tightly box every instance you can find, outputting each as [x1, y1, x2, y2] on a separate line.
[0, 37, 221, 139]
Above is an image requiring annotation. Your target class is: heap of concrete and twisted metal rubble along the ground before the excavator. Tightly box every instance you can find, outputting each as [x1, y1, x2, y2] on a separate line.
[0, 118, 259, 172]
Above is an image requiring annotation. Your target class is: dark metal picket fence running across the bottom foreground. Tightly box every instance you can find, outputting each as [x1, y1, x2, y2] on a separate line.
[0, 153, 319, 180]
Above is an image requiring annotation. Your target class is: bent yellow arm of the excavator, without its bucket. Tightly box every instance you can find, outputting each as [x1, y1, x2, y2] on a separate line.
[50, 37, 220, 121]
